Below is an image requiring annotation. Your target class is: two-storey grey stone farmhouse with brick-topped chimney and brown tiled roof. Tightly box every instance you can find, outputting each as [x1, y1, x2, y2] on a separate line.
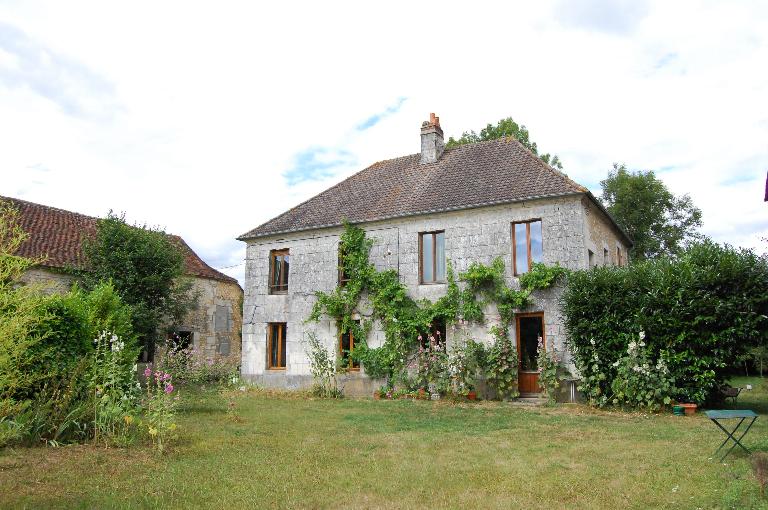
[238, 114, 632, 395]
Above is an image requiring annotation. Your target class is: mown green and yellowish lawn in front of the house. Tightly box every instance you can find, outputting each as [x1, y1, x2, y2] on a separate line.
[0, 378, 768, 508]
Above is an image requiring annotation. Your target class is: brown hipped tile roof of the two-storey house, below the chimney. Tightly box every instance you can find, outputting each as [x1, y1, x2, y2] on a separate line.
[238, 137, 588, 240]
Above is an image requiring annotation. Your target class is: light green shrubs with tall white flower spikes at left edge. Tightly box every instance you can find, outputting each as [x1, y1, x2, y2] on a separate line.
[0, 203, 182, 446]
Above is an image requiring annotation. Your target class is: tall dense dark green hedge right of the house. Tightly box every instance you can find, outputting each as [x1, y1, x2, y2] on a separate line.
[563, 242, 768, 405]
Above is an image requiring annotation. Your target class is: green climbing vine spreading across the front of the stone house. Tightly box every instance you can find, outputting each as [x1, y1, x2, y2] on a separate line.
[307, 224, 566, 378]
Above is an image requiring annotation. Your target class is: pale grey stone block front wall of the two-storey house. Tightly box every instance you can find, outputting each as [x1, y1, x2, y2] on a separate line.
[242, 196, 588, 388]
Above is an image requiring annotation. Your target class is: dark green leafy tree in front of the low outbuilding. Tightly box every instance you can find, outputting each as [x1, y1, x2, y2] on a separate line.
[81, 212, 197, 357]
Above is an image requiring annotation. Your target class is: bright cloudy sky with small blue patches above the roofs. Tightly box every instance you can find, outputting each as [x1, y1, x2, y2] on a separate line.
[0, 0, 768, 279]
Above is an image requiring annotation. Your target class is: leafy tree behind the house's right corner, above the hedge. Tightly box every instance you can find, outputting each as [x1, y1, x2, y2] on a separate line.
[600, 163, 701, 261]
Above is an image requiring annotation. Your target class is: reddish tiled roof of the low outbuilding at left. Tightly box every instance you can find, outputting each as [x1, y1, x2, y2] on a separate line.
[0, 196, 237, 283]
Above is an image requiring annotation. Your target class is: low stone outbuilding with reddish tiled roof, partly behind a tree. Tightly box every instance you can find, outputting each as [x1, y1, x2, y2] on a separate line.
[0, 196, 243, 357]
